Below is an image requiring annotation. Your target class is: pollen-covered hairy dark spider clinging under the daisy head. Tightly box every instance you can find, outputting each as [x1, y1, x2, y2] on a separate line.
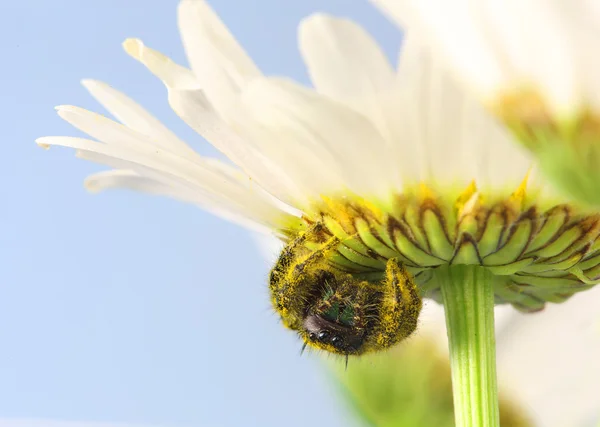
[269, 223, 422, 356]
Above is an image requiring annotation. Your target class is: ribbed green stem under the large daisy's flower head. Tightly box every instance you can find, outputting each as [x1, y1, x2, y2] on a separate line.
[436, 265, 500, 427]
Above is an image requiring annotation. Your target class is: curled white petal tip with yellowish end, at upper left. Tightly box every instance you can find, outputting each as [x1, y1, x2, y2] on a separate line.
[123, 38, 199, 89]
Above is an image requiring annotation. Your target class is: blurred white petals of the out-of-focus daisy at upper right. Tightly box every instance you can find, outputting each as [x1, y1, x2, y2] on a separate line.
[372, 0, 600, 116]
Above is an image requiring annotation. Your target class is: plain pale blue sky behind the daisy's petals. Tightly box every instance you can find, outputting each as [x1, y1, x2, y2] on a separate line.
[0, 0, 399, 427]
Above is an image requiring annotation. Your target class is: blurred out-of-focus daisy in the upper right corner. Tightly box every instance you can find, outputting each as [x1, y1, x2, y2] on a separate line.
[373, 0, 600, 206]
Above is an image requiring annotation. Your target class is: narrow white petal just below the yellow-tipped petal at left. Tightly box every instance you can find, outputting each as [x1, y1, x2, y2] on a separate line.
[82, 79, 196, 155]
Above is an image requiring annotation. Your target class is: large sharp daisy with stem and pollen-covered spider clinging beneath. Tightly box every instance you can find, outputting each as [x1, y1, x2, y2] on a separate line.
[37, 0, 600, 426]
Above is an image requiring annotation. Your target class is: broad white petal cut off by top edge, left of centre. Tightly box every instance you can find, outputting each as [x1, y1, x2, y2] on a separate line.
[178, 0, 261, 117]
